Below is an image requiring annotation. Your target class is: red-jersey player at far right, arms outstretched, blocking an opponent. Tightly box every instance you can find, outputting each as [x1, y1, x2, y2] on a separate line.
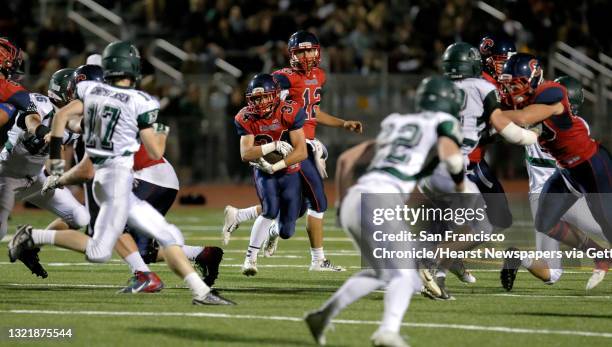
[499, 53, 612, 260]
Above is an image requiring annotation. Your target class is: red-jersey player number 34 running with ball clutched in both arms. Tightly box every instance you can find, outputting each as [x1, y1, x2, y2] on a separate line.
[234, 74, 307, 276]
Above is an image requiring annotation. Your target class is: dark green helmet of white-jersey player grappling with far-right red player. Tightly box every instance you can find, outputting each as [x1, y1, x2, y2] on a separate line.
[442, 42, 482, 79]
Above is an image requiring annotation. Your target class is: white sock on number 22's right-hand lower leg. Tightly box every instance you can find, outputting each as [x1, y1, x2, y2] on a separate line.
[380, 274, 415, 333]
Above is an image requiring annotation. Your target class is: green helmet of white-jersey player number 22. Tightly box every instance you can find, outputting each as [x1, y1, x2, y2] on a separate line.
[415, 76, 465, 118]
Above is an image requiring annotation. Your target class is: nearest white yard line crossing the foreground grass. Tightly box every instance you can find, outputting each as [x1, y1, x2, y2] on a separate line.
[0, 310, 612, 338]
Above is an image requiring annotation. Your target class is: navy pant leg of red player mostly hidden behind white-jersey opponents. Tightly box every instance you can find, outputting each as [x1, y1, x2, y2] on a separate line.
[467, 160, 512, 229]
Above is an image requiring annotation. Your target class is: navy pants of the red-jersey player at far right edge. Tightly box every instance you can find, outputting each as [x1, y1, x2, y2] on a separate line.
[535, 146, 612, 242]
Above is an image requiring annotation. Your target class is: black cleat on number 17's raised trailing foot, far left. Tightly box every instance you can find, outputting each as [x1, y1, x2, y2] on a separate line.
[8, 225, 48, 278]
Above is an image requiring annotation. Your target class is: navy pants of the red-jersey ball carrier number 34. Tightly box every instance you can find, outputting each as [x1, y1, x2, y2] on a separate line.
[253, 169, 302, 239]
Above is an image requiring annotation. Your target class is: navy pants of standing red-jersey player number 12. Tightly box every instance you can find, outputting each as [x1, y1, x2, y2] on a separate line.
[300, 146, 327, 212]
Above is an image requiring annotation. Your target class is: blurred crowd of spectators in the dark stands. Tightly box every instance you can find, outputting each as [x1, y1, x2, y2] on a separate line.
[0, 0, 612, 79]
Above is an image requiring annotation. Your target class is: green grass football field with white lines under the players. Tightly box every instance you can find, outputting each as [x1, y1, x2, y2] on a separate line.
[0, 209, 612, 347]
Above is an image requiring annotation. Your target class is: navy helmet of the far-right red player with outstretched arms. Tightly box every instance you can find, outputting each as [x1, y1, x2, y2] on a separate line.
[498, 53, 544, 108]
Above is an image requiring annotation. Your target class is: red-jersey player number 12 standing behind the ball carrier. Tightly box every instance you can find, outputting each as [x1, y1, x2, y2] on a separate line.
[223, 31, 362, 271]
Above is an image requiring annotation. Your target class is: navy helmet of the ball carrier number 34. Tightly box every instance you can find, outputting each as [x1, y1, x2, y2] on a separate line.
[245, 73, 281, 117]
